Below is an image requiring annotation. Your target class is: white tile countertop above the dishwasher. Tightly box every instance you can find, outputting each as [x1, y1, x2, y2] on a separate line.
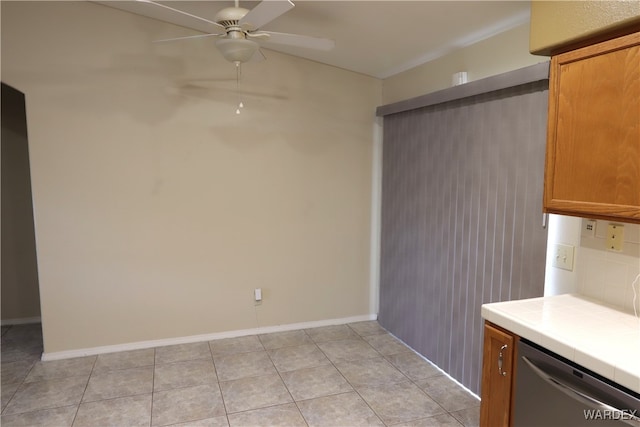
[482, 294, 640, 393]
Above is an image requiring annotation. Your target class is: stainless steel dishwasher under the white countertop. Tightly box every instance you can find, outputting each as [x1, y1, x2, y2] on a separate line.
[513, 340, 640, 427]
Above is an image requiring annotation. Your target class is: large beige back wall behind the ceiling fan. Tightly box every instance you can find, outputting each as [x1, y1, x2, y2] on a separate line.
[2, 2, 381, 352]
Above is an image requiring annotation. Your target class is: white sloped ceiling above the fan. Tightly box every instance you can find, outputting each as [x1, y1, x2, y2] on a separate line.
[100, 0, 530, 78]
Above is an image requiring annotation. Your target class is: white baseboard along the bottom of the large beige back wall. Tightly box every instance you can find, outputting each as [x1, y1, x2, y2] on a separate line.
[42, 314, 378, 361]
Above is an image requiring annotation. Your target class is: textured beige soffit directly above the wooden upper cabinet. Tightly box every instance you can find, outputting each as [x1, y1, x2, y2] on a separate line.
[529, 0, 640, 55]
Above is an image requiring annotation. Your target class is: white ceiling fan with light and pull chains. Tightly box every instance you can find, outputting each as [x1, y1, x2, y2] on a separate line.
[137, 0, 335, 66]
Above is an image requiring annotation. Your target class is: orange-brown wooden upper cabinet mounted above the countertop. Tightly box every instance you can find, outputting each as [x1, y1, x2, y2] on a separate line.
[544, 32, 640, 223]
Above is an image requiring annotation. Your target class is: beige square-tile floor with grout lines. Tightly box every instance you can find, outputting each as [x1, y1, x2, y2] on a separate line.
[1, 321, 479, 427]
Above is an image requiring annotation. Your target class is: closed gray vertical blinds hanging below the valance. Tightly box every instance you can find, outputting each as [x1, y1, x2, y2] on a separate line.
[379, 69, 548, 394]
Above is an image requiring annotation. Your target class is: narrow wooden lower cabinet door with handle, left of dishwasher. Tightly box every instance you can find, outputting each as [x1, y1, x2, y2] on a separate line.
[480, 323, 516, 427]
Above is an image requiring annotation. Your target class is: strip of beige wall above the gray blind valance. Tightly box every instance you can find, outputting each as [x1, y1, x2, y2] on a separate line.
[382, 23, 546, 104]
